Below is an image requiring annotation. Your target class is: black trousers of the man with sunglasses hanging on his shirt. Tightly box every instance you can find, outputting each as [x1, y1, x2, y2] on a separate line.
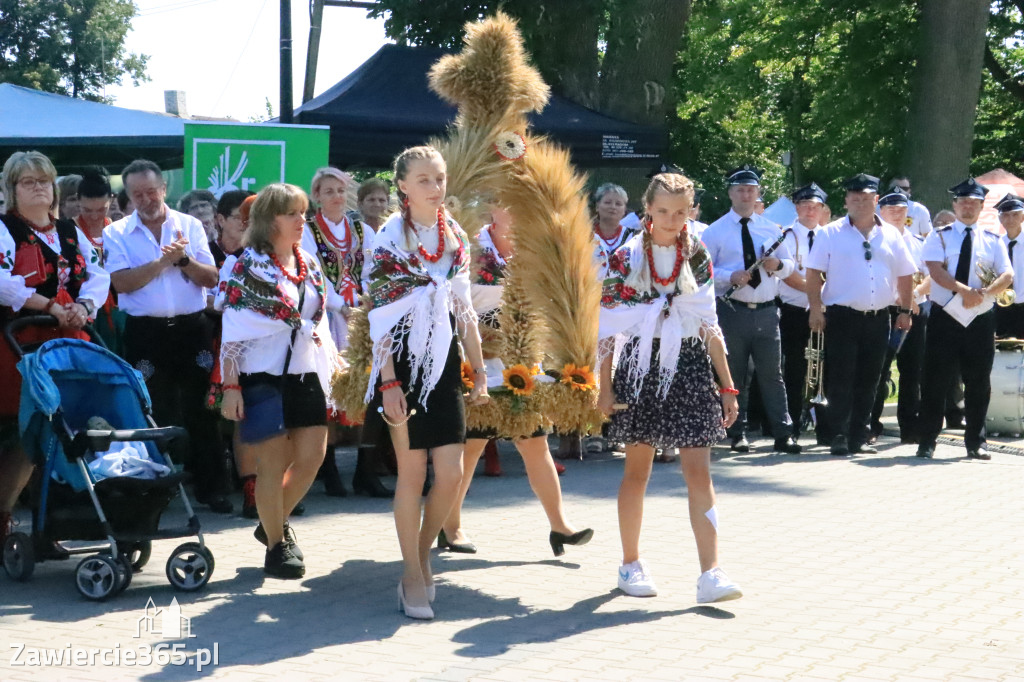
[825, 305, 889, 447]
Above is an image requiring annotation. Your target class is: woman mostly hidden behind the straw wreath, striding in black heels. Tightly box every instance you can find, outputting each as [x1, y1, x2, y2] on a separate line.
[437, 206, 594, 556]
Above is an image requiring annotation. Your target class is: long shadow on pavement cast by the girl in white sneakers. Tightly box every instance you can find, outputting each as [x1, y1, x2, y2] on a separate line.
[453, 590, 735, 658]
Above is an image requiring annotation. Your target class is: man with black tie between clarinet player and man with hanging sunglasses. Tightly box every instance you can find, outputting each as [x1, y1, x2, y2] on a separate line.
[778, 182, 830, 442]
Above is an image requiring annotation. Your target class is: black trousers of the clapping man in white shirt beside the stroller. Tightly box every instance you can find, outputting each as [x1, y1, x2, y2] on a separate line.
[124, 312, 228, 500]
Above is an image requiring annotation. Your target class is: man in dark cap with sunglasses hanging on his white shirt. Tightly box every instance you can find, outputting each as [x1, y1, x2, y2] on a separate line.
[806, 173, 916, 456]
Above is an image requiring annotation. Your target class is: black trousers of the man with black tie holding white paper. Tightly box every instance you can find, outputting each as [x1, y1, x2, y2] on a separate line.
[921, 303, 995, 450]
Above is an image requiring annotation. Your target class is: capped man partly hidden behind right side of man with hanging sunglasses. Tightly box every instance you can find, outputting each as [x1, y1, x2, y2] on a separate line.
[870, 185, 931, 443]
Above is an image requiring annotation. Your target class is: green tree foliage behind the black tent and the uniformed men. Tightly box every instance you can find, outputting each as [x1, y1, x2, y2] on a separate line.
[376, 0, 1024, 216]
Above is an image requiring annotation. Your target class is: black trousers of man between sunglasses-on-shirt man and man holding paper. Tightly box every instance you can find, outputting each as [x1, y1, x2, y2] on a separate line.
[871, 307, 928, 440]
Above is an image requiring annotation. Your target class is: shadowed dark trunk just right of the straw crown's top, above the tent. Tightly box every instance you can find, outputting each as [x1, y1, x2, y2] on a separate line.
[519, 0, 604, 109]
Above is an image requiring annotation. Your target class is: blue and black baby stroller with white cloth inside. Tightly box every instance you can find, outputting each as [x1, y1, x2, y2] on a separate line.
[3, 316, 214, 601]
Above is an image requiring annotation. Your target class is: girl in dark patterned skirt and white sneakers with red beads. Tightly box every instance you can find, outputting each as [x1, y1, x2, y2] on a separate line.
[598, 173, 741, 603]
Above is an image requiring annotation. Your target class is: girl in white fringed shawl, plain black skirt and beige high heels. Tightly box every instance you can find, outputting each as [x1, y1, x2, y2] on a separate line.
[364, 146, 487, 619]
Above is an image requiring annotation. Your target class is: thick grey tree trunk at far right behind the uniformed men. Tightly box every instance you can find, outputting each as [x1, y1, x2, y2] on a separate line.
[903, 0, 989, 212]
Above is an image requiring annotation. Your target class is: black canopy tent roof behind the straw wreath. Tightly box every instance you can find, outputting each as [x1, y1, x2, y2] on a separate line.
[295, 45, 668, 168]
